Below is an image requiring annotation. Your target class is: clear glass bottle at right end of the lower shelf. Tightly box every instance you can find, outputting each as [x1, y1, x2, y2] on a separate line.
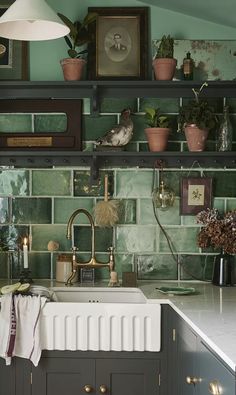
[217, 106, 233, 151]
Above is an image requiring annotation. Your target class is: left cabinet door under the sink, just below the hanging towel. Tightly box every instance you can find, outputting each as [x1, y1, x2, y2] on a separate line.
[32, 357, 95, 395]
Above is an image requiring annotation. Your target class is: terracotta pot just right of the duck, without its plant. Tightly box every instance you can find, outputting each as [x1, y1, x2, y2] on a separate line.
[145, 128, 170, 151]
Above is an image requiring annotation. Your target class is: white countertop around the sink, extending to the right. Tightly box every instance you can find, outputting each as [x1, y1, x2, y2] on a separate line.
[0, 280, 236, 372]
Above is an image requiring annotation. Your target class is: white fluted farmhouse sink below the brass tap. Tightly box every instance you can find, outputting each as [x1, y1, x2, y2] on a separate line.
[40, 287, 161, 352]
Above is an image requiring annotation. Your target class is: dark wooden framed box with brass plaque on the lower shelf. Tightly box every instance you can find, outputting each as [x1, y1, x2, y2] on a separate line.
[0, 99, 82, 151]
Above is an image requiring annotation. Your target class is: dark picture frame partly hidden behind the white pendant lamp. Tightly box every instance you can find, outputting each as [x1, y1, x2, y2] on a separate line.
[0, 0, 28, 80]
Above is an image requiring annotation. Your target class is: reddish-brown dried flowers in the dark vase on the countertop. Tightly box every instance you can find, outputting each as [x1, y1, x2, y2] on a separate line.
[196, 209, 236, 254]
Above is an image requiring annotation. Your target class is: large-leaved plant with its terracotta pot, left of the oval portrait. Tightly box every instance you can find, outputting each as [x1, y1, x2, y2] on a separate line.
[58, 12, 97, 81]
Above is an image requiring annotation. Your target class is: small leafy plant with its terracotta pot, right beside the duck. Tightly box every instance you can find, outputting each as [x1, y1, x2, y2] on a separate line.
[145, 107, 170, 151]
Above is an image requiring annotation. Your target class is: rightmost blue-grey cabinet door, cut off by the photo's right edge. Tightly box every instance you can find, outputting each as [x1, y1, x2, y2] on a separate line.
[198, 342, 235, 395]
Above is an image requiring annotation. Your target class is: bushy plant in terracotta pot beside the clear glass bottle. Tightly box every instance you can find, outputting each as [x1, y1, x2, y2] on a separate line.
[178, 82, 218, 151]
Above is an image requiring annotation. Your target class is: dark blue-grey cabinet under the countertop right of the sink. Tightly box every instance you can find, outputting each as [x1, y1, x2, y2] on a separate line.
[168, 308, 236, 395]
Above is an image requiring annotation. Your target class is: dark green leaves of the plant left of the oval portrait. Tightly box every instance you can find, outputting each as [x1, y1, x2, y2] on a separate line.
[58, 12, 97, 58]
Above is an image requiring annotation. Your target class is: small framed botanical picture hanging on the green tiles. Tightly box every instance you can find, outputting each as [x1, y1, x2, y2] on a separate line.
[180, 177, 212, 215]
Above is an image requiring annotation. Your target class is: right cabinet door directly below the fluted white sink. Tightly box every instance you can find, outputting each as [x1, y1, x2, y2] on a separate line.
[96, 359, 160, 395]
